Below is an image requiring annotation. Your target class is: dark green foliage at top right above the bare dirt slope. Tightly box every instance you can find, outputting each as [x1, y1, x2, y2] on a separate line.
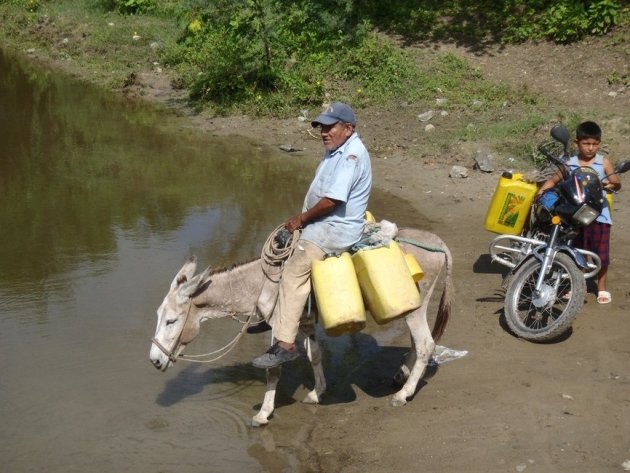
[357, 0, 624, 43]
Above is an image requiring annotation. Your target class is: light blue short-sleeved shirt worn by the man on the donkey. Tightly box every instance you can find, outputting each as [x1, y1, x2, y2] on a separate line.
[301, 132, 372, 253]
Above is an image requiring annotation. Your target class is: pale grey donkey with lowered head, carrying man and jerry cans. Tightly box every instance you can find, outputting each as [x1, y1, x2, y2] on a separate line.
[149, 229, 453, 426]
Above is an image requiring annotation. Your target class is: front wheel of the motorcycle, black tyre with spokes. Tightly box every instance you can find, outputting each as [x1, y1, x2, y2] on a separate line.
[505, 253, 586, 342]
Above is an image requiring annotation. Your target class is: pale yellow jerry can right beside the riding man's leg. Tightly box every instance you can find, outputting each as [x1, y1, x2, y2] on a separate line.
[311, 252, 366, 337]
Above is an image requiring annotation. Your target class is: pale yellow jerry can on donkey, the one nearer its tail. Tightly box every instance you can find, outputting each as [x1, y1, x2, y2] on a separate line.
[352, 241, 421, 324]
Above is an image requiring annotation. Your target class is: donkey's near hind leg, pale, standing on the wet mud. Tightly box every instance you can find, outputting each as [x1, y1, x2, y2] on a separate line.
[391, 297, 435, 406]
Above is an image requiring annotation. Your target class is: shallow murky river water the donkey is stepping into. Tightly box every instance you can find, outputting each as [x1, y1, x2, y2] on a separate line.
[0, 47, 428, 473]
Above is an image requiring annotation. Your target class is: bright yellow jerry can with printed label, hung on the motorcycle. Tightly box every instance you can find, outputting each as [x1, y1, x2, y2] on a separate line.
[484, 172, 538, 235]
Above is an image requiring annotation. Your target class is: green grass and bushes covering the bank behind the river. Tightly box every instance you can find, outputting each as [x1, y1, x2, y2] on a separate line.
[0, 0, 630, 160]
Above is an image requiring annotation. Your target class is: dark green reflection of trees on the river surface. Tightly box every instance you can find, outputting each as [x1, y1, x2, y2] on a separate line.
[0, 47, 308, 294]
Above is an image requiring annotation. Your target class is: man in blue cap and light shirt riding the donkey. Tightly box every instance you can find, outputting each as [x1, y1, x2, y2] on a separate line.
[248, 102, 372, 368]
